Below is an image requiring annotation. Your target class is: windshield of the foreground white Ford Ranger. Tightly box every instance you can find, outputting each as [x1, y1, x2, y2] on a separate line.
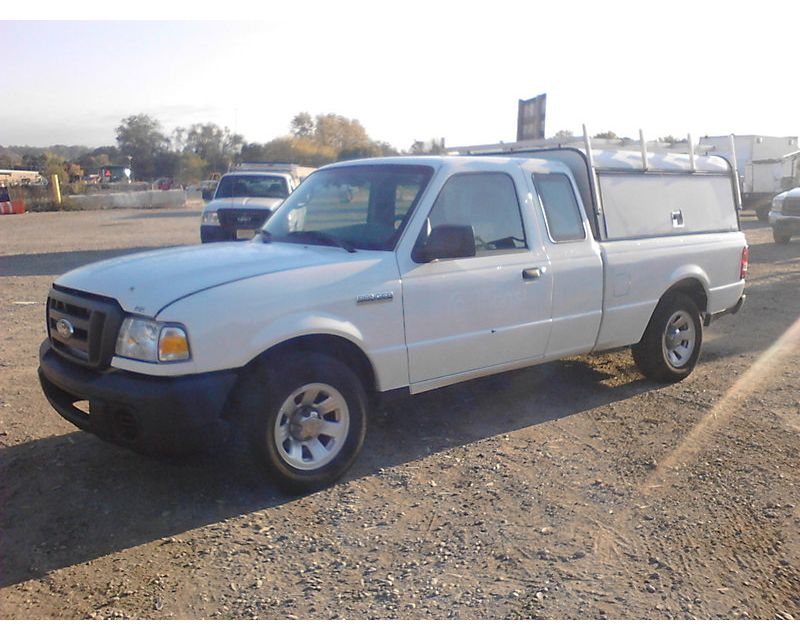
[263, 165, 433, 251]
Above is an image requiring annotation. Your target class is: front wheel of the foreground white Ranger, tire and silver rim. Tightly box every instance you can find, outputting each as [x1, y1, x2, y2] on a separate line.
[241, 352, 368, 494]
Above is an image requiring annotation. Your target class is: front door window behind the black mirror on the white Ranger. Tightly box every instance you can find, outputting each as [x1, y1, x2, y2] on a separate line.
[418, 173, 527, 256]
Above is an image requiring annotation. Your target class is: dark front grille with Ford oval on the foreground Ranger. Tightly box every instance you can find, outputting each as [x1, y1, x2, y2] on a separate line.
[47, 285, 123, 369]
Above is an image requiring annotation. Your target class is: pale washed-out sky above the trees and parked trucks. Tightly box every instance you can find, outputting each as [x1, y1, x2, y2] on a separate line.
[0, 0, 800, 149]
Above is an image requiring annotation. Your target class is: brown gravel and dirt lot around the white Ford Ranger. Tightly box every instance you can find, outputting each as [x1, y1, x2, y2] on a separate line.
[0, 206, 800, 619]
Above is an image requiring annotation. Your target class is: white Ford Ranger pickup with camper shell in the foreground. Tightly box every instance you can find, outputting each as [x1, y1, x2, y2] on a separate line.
[40, 149, 748, 491]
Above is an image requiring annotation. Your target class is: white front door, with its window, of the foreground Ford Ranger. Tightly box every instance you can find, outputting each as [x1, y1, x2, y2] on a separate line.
[400, 171, 551, 388]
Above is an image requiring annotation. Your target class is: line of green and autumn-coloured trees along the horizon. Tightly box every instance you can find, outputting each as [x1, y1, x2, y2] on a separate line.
[0, 111, 444, 184]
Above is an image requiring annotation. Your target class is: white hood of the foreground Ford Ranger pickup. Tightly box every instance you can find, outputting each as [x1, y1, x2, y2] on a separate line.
[55, 241, 349, 318]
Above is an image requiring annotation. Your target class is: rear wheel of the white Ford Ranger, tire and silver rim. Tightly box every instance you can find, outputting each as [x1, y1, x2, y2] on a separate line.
[631, 293, 703, 382]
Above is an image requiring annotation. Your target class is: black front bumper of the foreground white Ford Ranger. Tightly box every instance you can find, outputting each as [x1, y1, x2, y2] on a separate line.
[39, 340, 237, 454]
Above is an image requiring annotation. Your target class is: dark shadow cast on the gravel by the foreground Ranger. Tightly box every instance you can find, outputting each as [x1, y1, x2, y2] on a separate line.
[0, 360, 655, 587]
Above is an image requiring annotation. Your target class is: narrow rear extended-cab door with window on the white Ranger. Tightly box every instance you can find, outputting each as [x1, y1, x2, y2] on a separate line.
[529, 173, 603, 358]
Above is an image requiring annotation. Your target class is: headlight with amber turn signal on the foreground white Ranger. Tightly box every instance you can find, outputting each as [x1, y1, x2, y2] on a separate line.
[116, 317, 191, 362]
